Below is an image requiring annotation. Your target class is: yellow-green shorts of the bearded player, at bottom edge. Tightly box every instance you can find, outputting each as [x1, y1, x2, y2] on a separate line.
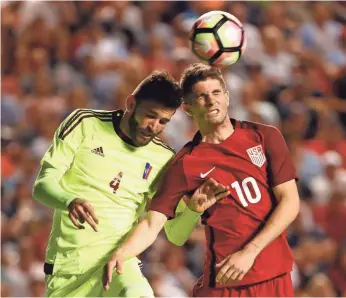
[46, 258, 154, 297]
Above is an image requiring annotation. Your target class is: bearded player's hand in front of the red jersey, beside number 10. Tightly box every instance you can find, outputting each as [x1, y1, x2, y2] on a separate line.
[187, 178, 230, 213]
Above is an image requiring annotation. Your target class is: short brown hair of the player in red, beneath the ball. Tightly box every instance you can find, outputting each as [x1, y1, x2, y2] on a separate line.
[180, 63, 226, 97]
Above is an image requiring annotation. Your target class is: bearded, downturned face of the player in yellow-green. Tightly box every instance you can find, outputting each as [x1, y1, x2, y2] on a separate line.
[129, 100, 175, 146]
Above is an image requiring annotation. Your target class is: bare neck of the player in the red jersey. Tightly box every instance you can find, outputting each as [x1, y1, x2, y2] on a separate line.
[199, 117, 234, 144]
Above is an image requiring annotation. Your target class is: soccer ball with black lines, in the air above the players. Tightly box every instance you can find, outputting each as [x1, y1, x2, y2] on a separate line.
[190, 11, 246, 67]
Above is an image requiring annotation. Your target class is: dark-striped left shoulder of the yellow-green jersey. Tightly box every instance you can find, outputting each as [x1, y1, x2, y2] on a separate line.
[59, 109, 114, 139]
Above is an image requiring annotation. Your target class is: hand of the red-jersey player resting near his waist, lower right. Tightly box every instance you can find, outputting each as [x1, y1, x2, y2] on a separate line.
[216, 249, 257, 285]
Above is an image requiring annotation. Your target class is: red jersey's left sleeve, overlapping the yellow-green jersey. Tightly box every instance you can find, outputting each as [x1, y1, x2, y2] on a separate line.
[149, 160, 188, 219]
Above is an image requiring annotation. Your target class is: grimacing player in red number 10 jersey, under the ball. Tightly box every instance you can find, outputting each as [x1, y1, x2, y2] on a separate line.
[105, 64, 299, 297]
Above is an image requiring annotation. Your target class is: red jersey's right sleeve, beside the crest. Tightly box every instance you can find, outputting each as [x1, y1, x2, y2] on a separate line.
[264, 126, 297, 187]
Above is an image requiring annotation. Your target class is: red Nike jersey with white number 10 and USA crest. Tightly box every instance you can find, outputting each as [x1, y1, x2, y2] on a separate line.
[150, 119, 296, 287]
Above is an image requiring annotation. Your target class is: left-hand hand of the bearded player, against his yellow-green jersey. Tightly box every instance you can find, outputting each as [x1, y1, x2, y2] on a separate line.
[68, 199, 99, 232]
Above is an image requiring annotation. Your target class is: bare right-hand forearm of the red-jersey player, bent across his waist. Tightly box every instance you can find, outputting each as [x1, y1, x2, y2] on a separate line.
[245, 183, 299, 254]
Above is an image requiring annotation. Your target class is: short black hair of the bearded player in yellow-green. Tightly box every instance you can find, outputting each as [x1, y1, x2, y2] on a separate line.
[132, 71, 182, 109]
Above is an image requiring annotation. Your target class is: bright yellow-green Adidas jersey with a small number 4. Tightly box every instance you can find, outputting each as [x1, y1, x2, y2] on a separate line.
[34, 109, 174, 274]
